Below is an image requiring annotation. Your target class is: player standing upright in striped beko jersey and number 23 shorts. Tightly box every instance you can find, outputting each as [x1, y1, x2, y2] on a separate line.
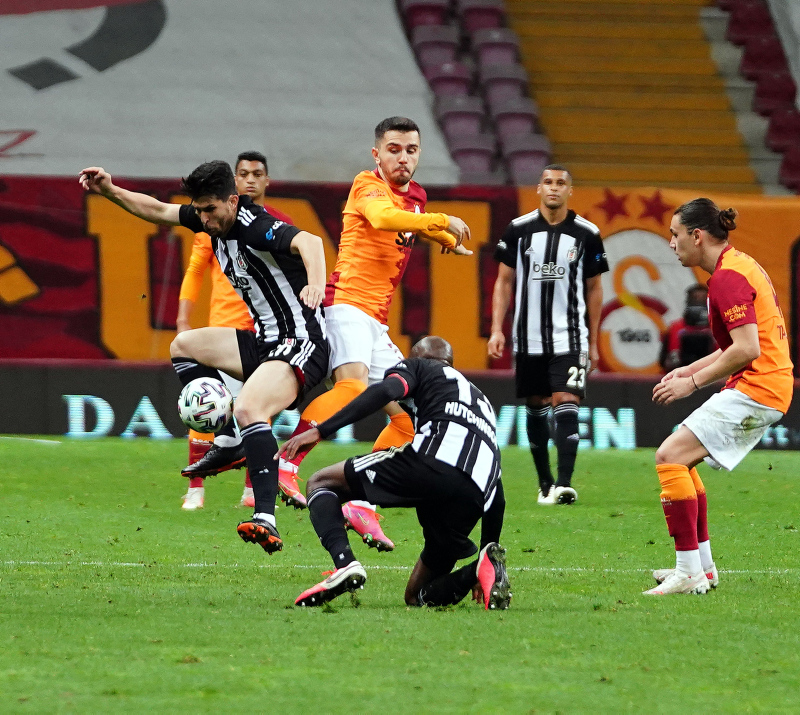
[488, 164, 608, 504]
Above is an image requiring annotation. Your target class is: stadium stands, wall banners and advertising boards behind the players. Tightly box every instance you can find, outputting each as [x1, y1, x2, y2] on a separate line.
[0, 0, 800, 448]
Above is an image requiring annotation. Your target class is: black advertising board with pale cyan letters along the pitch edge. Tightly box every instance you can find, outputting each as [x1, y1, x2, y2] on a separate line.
[0, 360, 800, 450]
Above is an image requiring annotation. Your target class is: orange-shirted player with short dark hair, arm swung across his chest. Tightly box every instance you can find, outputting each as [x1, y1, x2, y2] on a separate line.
[280, 117, 472, 550]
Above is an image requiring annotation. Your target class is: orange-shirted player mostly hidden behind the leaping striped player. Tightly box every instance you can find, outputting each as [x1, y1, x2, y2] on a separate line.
[176, 151, 294, 511]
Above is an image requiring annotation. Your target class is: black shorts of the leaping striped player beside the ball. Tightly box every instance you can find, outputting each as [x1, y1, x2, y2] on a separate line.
[236, 330, 330, 409]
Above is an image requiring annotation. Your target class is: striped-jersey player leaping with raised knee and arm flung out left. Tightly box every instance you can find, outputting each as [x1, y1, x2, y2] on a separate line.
[79, 161, 329, 553]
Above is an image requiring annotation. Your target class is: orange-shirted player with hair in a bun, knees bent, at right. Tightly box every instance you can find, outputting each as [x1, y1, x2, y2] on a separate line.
[645, 199, 794, 596]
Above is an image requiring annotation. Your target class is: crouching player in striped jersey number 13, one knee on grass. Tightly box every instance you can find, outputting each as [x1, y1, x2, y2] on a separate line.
[281, 336, 510, 609]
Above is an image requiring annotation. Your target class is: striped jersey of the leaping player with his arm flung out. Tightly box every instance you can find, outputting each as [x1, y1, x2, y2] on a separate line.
[180, 196, 325, 342]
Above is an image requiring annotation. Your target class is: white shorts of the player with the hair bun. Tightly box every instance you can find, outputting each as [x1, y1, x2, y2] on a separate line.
[682, 389, 783, 471]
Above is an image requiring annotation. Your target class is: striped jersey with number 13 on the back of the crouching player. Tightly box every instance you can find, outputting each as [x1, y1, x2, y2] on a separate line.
[384, 358, 500, 503]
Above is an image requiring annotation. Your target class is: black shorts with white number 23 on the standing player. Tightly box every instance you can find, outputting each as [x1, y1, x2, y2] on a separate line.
[515, 353, 589, 399]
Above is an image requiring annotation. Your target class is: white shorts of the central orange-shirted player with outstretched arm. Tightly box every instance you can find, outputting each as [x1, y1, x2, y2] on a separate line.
[325, 304, 403, 385]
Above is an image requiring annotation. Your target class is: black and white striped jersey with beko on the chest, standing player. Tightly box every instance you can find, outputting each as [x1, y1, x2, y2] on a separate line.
[494, 209, 608, 355]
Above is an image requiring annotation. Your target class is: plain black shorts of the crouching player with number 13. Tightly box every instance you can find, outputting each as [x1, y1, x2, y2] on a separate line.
[344, 444, 483, 572]
